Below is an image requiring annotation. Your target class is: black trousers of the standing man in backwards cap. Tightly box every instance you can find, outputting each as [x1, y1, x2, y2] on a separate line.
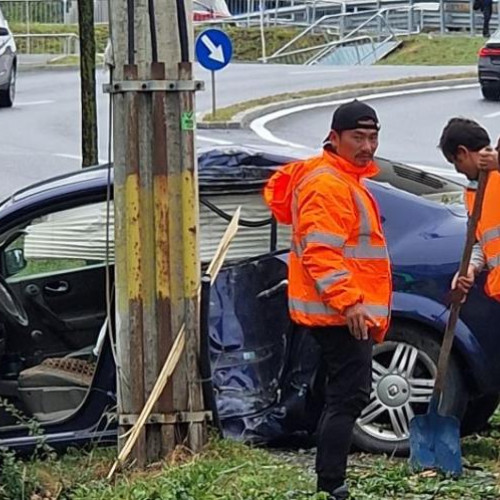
[310, 327, 373, 493]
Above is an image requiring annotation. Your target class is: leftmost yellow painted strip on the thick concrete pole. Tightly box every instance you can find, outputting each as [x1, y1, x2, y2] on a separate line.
[125, 174, 142, 299]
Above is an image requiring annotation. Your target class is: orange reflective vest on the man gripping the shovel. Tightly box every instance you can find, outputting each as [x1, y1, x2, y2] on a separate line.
[465, 172, 500, 301]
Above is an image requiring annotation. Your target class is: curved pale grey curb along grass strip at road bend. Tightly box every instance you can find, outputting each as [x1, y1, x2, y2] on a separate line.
[197, 76, 478, 130]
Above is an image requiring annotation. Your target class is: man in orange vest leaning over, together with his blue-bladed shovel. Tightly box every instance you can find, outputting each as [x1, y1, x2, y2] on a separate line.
[410, 118, 494, 476]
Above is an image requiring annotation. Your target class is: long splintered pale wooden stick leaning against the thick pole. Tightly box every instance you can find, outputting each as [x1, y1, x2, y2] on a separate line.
[107, 206, 241, 480]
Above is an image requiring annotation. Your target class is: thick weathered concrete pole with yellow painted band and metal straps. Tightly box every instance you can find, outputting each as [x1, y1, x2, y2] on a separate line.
[110, 0, 206, 466]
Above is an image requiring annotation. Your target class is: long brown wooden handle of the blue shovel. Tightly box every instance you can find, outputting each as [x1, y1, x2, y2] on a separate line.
[433, 170, 488, 401]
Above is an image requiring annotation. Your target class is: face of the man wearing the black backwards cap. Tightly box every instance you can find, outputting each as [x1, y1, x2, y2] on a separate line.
[330, 123, 378, 168]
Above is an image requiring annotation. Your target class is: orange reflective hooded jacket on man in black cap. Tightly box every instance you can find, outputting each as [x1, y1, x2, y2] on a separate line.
[264, 150, 392, 341]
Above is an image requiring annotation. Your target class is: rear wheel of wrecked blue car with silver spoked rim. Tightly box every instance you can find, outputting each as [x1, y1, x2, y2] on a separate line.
[353, 322, 468, 456]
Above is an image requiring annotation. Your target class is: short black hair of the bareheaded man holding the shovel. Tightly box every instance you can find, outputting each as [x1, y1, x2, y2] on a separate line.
[439, 118, 491, 163]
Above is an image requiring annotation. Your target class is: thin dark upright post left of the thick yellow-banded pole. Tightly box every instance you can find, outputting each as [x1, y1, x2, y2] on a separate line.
[78, 0, 99, 167]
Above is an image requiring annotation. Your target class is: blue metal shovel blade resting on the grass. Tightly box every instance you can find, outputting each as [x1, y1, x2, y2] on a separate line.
[410, 411, 462, 476]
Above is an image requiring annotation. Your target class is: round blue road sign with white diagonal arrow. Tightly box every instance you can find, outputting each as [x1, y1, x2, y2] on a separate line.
[195, 29, 233, 71]
